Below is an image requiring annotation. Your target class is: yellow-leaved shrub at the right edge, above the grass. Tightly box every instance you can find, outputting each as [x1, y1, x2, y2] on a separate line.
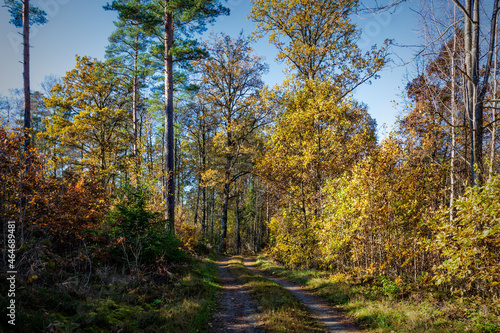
[432, 176, 500, 296]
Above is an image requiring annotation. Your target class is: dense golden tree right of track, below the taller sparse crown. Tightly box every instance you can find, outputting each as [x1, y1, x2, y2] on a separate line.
[257, 83, 376, 266]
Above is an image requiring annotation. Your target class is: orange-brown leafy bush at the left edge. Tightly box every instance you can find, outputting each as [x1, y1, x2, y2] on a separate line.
[0, 127, 108, 264]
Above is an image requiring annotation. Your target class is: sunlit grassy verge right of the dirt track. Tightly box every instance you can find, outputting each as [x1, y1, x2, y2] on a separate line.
[258, 256, 500, 333]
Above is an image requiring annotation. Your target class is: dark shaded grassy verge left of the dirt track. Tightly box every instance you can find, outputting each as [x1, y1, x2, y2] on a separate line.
[0, 260, 217, 333]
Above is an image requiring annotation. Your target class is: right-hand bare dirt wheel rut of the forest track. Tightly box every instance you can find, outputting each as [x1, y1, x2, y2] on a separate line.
[243, 258, 362, 333]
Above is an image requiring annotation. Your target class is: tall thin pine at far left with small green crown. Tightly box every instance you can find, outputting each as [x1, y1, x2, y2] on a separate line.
[4, 0, 47, 152]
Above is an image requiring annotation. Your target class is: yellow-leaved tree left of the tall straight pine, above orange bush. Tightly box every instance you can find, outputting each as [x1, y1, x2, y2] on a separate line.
[43, 56, 131, 184]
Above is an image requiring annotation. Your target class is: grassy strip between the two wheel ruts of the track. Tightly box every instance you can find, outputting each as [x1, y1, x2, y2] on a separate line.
[229, 257, 323, 332]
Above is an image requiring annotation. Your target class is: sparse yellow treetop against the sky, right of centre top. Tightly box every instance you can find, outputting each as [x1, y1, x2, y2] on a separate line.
[250, 0, 389, 100]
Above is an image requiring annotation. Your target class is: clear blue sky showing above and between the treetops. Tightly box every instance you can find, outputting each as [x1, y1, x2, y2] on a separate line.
[0, 0, 418, 136]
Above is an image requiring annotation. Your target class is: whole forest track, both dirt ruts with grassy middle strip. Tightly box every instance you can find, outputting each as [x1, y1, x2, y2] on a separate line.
[211, 256, 360, 332]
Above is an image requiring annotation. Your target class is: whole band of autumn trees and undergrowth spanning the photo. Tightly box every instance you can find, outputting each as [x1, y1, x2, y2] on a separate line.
[0, 0, 500, 316]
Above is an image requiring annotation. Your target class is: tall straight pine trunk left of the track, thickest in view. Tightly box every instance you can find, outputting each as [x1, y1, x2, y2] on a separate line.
[164, 0, 175, 233]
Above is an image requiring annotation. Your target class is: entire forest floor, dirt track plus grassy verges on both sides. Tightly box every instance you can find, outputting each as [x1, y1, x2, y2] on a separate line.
[0, 255, 500, 333]
